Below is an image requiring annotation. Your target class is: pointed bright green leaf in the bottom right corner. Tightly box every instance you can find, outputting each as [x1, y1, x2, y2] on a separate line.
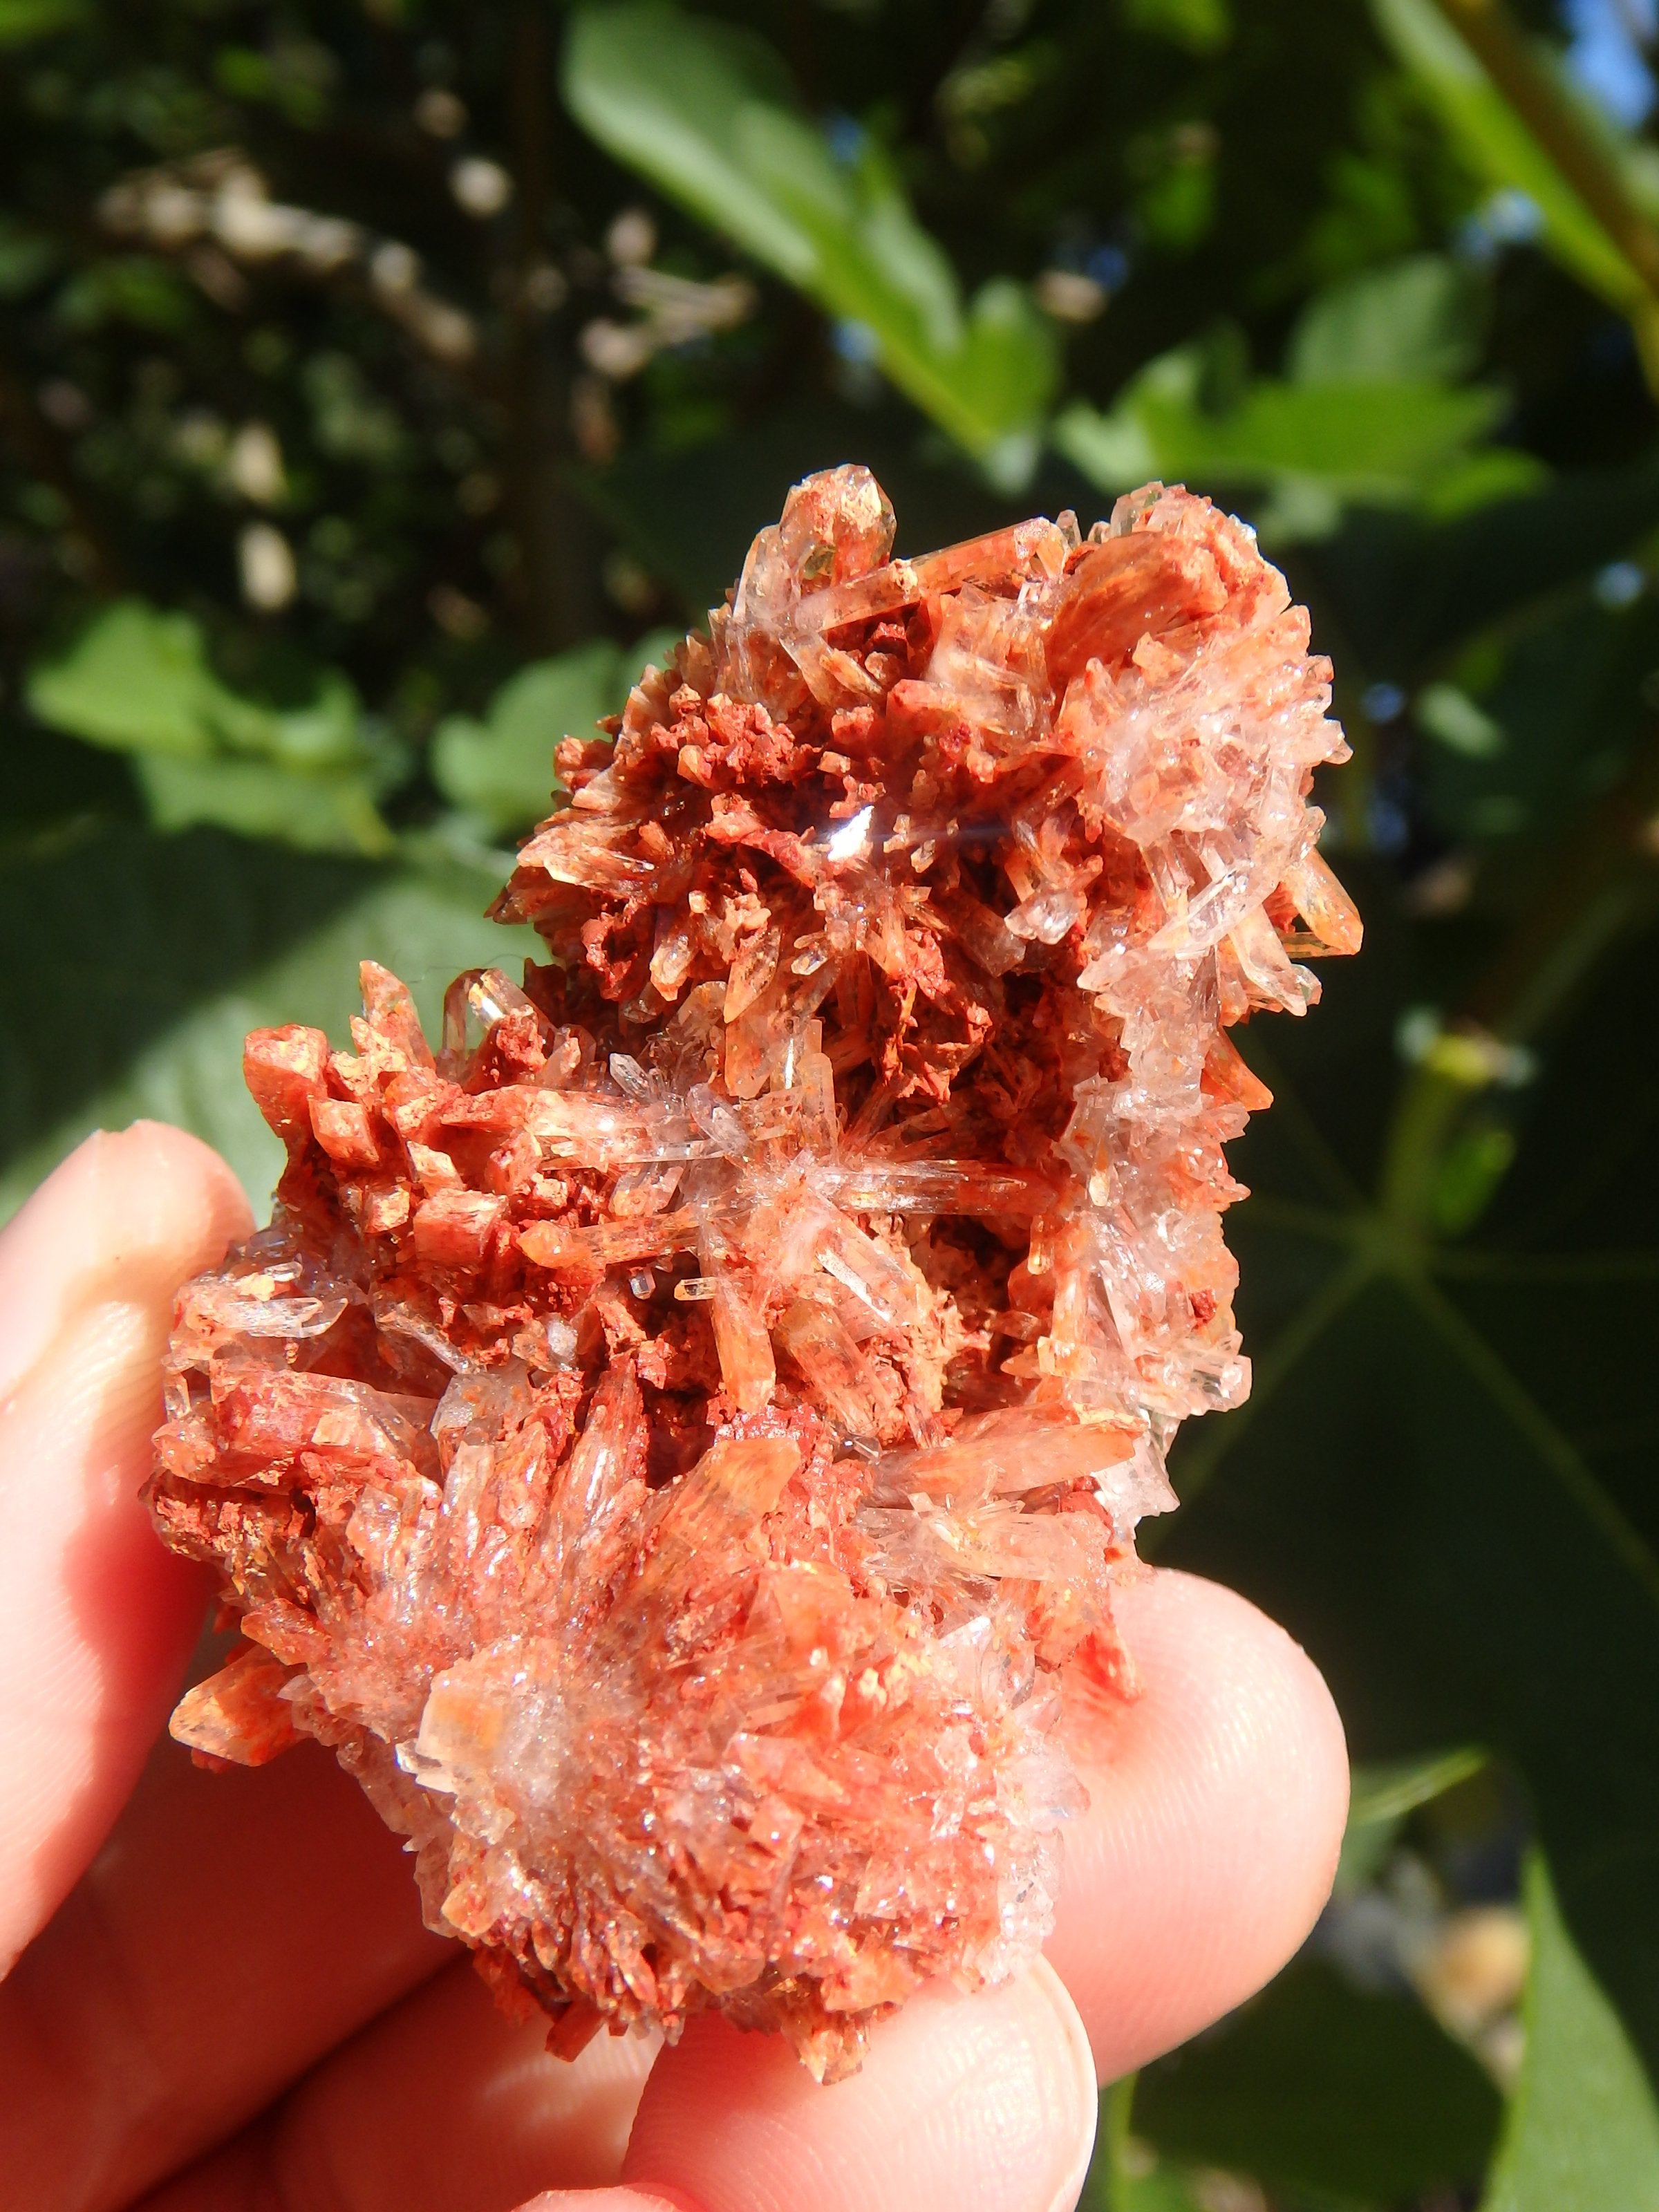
[1482, 1856, 1659, 2212]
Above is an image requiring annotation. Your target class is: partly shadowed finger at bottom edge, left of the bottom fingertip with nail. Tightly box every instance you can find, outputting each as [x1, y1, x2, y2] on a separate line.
[133, 1960, 657, 2212]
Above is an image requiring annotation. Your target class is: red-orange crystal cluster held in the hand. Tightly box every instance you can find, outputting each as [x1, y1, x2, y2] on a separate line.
[151, 467, 1358, 2077]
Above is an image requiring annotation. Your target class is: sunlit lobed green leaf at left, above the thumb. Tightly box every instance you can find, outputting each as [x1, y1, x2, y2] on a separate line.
[26, 599, 398, 854]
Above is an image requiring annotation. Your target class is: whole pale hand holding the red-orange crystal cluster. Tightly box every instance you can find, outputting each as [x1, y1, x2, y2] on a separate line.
[0, 1124, 1347, 2212]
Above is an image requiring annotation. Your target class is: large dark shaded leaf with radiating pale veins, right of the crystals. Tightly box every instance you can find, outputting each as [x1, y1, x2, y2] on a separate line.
[1154, 898, 1659, 2097]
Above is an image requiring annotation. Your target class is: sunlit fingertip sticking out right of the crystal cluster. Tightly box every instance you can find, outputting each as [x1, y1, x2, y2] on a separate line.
[1047, 1571, 1347, 2081]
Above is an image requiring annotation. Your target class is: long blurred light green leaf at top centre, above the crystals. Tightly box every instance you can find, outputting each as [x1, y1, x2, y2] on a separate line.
[564, 0, 1058, 462]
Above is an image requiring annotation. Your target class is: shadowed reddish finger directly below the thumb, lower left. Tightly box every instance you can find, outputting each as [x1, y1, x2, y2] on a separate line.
[0, 1741, 456, 2212]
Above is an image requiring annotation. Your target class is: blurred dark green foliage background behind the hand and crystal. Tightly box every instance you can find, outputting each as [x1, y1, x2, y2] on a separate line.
[0, 0, 1659, 2212]
